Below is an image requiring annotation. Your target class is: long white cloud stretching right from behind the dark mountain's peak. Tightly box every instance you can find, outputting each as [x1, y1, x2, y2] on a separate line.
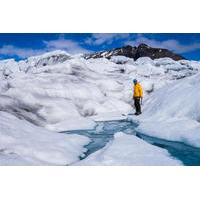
[126, 35, 200, 53]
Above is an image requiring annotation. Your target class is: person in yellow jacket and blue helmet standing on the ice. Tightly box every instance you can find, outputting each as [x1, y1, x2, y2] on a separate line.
[133, 79, 143, 115]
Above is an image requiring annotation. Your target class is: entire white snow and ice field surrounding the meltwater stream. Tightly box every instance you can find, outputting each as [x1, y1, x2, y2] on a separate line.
[0, 51, 200, 165]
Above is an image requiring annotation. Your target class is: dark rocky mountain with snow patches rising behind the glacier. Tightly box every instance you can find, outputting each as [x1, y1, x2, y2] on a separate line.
[85, 44, 185, 61]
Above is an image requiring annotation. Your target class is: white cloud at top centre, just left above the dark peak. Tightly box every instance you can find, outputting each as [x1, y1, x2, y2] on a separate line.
[85, 33, 129, 45]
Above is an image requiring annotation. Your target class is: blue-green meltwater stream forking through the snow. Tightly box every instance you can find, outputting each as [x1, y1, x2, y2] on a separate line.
[64, 120, 200, 166]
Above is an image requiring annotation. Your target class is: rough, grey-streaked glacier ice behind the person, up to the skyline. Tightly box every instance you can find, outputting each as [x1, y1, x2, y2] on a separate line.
[0, 51, 198, 130]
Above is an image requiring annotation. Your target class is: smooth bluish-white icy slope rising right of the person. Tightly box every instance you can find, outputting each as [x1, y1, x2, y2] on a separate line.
[131, 73, 200, 147]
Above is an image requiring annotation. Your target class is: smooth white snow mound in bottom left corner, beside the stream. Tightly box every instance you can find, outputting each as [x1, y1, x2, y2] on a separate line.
[0, 112, 89, 165]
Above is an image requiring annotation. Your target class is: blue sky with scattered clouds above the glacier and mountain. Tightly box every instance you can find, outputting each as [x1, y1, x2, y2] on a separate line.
[0, 33, 200, 60]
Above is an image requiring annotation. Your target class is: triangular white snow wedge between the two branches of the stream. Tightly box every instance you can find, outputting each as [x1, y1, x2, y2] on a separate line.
[74, 132, 182, 166]
